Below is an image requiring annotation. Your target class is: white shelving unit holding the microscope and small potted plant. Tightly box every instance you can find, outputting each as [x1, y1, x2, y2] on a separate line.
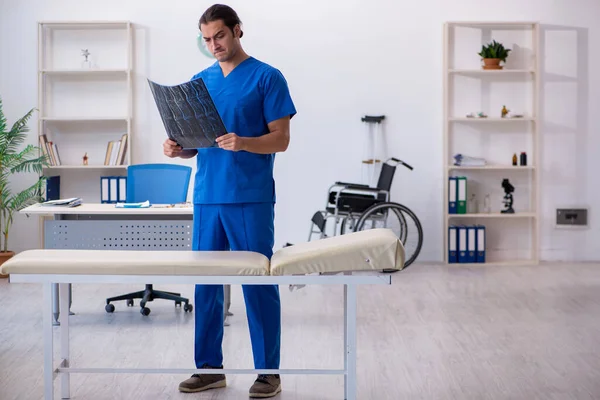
[443, 22, 540, 266]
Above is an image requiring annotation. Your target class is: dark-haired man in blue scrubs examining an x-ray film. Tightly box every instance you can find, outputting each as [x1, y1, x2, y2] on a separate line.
[163, 4, 296, 398]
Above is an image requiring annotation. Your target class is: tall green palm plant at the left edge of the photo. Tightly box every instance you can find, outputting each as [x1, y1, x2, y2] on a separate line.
[0, 98, 48, 278]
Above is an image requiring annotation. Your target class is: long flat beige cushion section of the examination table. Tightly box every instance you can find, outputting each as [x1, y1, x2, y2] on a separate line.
[2, 249, 269, 275]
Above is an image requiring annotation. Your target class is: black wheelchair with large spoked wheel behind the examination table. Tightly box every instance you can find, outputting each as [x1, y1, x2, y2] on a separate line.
[308, 157, 423, 272]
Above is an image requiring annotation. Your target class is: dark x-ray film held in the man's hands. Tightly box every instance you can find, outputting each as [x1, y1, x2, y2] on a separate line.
[148, 78, 227, 149]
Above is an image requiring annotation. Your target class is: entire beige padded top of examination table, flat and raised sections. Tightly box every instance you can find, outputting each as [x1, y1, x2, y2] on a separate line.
[1, 229, 404, 276]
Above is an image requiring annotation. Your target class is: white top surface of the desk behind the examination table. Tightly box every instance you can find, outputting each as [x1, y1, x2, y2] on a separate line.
[20, 203, 194, 215]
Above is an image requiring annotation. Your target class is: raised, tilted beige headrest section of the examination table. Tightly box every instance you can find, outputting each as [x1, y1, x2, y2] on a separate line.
[271, 229, 405, 275]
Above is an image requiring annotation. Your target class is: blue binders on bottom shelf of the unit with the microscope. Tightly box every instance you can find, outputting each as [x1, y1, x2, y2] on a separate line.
[448, 225, 486, 264]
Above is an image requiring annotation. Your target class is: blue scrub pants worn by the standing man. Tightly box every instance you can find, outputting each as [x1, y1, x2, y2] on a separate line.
[192, 203, 281, 369]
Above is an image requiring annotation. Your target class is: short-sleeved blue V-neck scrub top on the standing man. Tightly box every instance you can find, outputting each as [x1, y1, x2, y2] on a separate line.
[192, 57, 296, 204]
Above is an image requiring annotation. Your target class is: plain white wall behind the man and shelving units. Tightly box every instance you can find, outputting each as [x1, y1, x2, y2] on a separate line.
[0, 0, 600, 261]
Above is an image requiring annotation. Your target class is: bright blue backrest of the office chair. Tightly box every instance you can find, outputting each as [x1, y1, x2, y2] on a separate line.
[127, 164, 192, 204]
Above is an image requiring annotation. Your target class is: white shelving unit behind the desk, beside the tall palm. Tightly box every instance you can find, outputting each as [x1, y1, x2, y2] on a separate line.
[38, 21, 133, 201]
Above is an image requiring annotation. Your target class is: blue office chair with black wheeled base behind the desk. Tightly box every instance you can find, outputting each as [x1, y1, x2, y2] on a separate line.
[105, 164, 193, 315]
